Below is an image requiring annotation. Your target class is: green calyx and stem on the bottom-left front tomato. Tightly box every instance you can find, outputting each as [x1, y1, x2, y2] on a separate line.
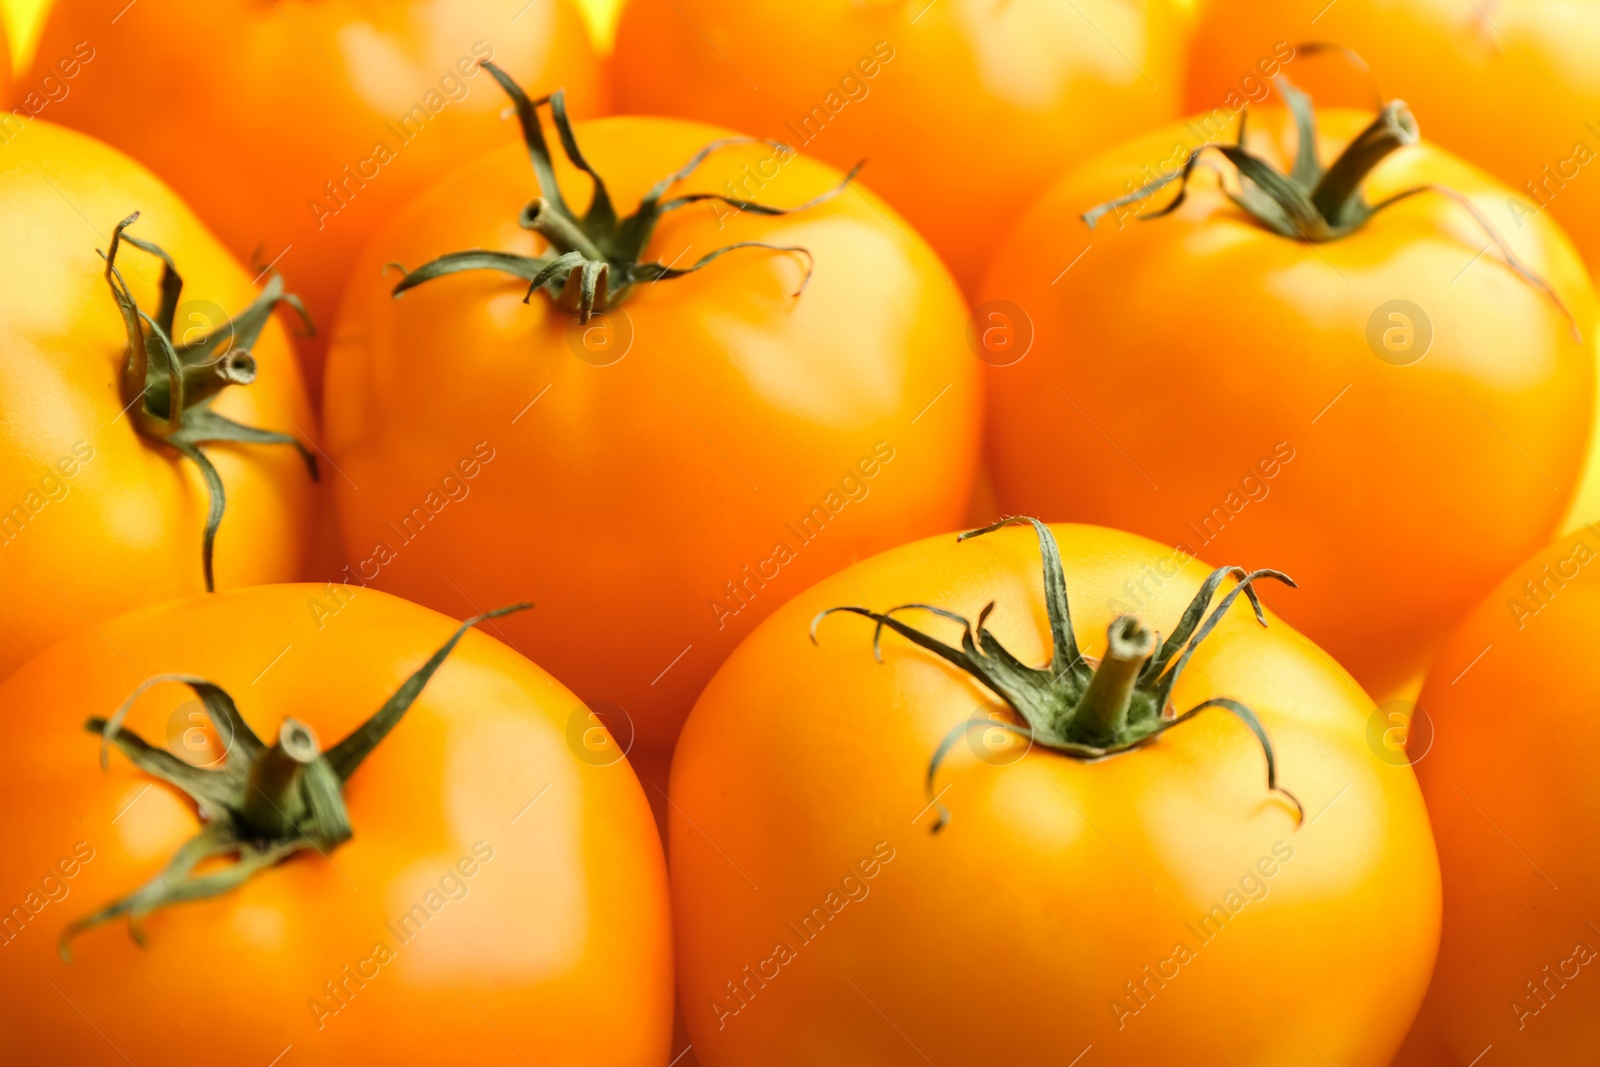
[58, 603, 531, 961]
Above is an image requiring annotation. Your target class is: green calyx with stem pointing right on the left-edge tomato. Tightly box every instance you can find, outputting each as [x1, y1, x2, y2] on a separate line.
[101, 211, 317, 592]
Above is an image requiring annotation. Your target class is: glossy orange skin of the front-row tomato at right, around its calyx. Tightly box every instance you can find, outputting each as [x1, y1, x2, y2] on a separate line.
[669, 525, 1438, 1067]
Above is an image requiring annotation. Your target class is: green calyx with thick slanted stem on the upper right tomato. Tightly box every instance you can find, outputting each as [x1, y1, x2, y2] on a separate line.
[1083, 75, 1582, 341]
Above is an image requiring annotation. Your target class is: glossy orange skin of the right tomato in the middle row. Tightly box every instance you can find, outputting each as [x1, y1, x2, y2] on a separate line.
[986, 109, 1600, 696]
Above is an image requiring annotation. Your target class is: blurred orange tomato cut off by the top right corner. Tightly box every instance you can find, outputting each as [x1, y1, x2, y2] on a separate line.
[1186, 0, 1600, 283]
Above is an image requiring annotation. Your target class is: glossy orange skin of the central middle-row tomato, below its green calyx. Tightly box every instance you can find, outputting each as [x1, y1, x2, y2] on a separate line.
[326, 118, 979, 745]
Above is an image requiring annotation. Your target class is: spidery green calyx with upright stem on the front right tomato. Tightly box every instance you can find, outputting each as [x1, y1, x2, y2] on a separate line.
[811, 517, 1304, 832]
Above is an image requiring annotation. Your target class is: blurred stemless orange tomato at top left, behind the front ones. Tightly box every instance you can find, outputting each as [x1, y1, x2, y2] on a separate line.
[26, 0, 605, 397]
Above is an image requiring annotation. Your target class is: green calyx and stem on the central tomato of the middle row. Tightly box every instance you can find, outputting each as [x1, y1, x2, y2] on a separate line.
[394, 62, 861, 322]
